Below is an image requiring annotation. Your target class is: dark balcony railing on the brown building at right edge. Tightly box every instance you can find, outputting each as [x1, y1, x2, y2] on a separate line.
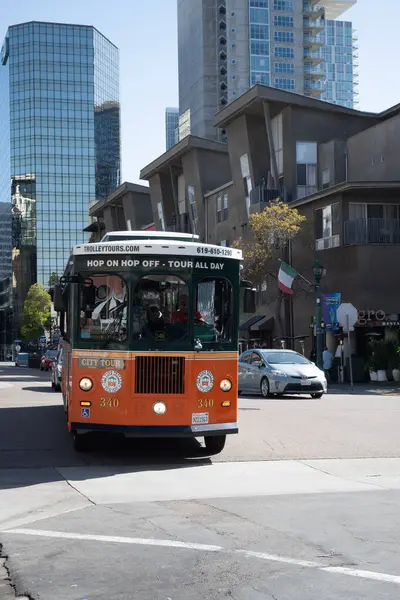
[344, 219, 400, 246]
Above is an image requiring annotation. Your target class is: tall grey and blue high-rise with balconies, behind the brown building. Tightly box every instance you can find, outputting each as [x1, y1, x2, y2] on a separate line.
[178, 0, 357, 138]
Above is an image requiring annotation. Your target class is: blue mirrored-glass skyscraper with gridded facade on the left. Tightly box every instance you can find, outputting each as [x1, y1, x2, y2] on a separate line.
[0, 22, 120, 313]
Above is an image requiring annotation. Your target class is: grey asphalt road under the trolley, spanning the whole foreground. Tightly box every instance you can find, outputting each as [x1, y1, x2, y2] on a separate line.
[0, 360, 400, 600]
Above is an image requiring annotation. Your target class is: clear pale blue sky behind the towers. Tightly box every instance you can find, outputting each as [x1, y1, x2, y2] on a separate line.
[0, 0, 400, 183]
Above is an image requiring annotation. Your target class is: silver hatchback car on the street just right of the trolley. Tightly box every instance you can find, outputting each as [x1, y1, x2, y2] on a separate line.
[239, 349, 327, 398]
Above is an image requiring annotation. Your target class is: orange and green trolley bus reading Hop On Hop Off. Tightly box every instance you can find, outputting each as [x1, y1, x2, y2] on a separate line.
[54, 231, 250, 453]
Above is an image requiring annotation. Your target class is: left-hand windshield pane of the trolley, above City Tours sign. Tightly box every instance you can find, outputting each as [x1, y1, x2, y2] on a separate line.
[79, 275, 128, 346]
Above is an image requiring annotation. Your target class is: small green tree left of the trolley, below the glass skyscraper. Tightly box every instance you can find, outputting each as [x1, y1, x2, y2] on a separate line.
[21, 283, 51, 342]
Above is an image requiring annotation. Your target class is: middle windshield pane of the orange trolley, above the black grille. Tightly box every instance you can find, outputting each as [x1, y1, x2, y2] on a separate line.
[132, 275, 189, 342]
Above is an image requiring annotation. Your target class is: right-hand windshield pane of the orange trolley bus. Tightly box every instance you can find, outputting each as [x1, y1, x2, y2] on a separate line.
[195, 277, 234, 342]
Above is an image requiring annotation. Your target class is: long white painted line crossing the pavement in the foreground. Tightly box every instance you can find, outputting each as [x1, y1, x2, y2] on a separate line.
[3, 528, 400, 585]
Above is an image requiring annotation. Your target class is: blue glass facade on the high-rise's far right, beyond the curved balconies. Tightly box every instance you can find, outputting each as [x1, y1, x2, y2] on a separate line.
[322, 20, 354, 108]
